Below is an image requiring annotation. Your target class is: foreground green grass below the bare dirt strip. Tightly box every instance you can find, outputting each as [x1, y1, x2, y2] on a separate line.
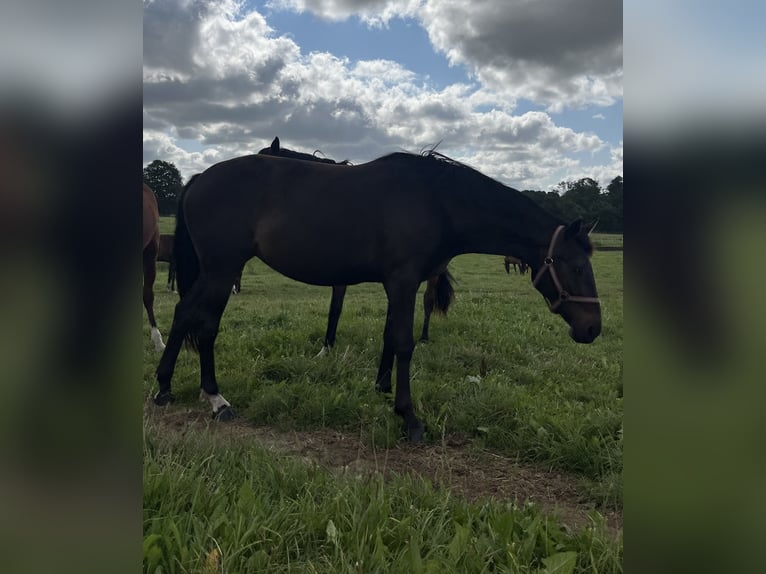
[143, 424, 622, 574]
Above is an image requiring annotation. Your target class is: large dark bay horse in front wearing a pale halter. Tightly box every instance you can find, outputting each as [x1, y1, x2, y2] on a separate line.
[154, 151, 601, 442]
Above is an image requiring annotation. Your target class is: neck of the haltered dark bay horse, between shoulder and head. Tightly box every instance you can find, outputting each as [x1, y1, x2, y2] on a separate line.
[451, 184, 559, 261]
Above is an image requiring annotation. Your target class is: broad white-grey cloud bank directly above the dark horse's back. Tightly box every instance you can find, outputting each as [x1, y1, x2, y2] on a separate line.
[144, 0, 622, 188]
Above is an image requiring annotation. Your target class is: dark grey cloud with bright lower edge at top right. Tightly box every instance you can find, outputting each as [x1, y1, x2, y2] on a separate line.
[270, 0, 622, 112]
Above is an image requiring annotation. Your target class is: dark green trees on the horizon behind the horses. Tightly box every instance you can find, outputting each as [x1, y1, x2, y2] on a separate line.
[143, 159, 622, 233]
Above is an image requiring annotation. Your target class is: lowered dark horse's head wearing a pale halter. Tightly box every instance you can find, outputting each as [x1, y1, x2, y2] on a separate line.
[530, 220, 601, 343]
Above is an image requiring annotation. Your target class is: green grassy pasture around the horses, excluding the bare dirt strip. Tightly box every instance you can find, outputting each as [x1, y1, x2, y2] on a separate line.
[144, 219, 623, 574]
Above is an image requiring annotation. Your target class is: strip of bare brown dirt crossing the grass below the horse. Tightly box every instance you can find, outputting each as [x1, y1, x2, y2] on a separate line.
[144, 406, 623, 534]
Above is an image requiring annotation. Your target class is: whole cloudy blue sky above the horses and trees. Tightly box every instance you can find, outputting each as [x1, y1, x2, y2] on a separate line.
[143, 0, 623, 191]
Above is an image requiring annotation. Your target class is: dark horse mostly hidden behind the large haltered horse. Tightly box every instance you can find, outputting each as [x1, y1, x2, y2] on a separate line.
[258, 138, 455, 357]
